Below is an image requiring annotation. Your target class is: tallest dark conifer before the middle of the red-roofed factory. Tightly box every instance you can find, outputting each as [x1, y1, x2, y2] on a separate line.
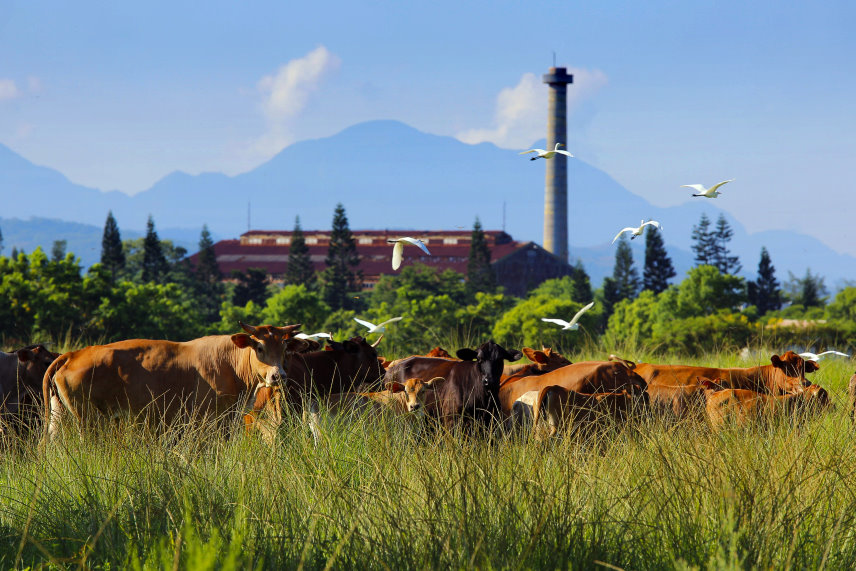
[322, 203, 362, 310]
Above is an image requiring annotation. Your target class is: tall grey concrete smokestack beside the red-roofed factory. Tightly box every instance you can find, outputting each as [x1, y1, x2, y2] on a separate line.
[542, 67, 574, 262]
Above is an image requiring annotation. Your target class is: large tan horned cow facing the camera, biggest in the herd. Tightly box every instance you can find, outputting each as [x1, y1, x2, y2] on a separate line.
[42, 323, 306, 435]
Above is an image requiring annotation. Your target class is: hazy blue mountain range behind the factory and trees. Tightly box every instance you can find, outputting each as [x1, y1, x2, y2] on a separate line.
[0, 121, 856, 287]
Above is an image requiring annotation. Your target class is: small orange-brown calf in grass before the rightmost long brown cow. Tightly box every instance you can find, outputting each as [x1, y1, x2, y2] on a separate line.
[700, 379, 832, 430]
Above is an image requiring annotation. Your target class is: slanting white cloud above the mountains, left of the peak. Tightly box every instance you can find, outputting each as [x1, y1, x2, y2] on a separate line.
[256, 46, 340, 155]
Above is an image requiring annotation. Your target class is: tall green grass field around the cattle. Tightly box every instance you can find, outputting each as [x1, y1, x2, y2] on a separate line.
[0, 346, 856, 569]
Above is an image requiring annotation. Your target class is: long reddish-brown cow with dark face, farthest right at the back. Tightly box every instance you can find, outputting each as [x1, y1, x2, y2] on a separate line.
[635, 351, 819, 394]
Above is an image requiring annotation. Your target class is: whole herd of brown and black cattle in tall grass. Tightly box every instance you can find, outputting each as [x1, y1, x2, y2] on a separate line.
[0, 323, 844, 443]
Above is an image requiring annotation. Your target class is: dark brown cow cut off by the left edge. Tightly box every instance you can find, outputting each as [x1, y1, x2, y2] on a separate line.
[0, 345, 59, 432]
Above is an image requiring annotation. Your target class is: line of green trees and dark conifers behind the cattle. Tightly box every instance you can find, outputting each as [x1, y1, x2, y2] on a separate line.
[0, 208, 844, 352]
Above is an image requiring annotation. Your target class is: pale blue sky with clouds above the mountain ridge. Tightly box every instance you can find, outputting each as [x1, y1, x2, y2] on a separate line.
[0, 0, 856, 255]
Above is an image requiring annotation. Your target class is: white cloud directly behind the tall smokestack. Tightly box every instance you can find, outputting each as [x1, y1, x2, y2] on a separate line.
[457, 68, 607, 148]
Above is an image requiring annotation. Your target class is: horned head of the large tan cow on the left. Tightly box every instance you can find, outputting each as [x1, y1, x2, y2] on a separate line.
[232, 321, 310, 387]
